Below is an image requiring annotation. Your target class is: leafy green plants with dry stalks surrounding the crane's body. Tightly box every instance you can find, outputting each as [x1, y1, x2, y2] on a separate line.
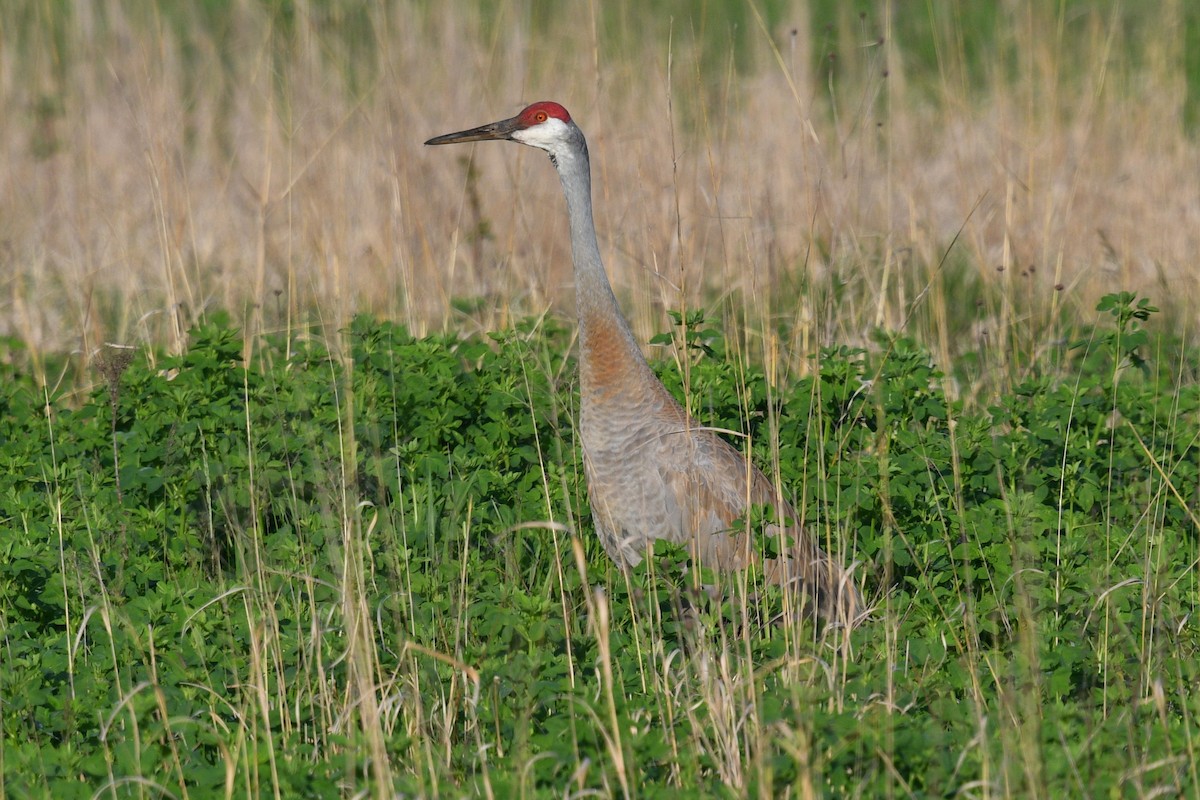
[0, 294, 1200, 798]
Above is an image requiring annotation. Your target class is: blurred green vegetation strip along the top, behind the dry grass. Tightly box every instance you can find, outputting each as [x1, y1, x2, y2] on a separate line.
[16, 0, 1200, 115]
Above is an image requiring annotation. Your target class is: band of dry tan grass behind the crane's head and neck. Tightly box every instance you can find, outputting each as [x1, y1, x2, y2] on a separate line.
[0, 0, 1200, 379]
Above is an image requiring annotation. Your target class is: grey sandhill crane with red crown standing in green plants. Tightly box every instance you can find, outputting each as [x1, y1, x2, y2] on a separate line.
[425, 102, 863, 625]
